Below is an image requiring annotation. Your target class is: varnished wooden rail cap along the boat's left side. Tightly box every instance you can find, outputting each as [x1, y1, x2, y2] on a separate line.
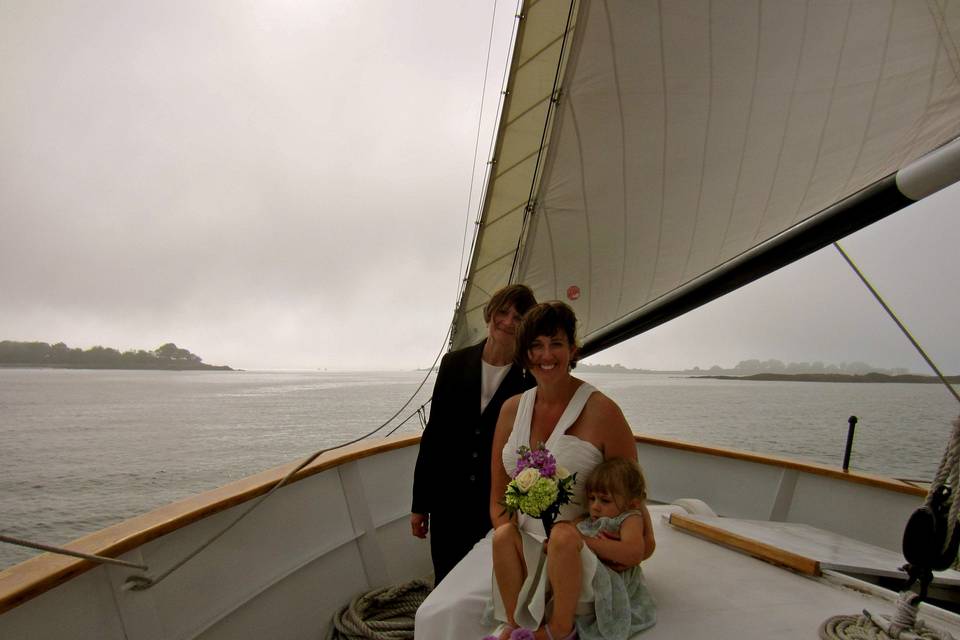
[0, 436, 420, 614]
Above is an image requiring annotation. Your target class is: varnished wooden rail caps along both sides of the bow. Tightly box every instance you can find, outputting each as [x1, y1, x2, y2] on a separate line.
[0, 434, 926, 615]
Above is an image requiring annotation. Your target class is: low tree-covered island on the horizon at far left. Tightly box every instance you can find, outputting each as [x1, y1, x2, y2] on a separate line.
[0, 340, 233, 371]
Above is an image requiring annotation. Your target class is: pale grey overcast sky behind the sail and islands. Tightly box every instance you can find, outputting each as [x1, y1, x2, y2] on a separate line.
[0, 0, 960, 373]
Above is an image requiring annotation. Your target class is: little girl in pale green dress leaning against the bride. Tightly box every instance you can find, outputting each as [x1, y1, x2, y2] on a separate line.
[576, 458, 657, 640]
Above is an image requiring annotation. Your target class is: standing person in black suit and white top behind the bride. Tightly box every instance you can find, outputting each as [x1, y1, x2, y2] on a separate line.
[410, 284, 536, 584]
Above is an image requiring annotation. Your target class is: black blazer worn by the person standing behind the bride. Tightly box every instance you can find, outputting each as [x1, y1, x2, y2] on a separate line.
[411, 340, 536, 517]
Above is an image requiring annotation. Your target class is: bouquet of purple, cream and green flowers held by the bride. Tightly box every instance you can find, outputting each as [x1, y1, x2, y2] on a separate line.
[502, 444, 577, 537]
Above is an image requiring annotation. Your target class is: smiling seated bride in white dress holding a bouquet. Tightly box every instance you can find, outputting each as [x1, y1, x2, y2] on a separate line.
[416, 302, 653, 640]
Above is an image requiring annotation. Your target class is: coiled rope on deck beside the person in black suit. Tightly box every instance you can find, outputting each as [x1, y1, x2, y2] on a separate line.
[326, 580, 430, 640]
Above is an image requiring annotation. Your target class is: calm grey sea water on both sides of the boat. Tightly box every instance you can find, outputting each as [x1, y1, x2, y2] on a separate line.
[0, 369, 958, 568]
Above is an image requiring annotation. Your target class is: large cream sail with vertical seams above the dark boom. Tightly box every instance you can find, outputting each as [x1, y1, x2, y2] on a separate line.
[452, 0, 960, 353]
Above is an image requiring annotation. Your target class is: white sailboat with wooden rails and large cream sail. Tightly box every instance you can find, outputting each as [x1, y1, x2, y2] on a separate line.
[0, 0, 960, 640]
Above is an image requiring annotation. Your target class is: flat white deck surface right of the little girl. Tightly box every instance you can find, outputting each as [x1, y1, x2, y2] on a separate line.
[637, 506, 960, 640]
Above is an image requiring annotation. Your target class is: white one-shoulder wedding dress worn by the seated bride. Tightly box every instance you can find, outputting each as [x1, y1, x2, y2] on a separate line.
[414, 382, 603, 640]
